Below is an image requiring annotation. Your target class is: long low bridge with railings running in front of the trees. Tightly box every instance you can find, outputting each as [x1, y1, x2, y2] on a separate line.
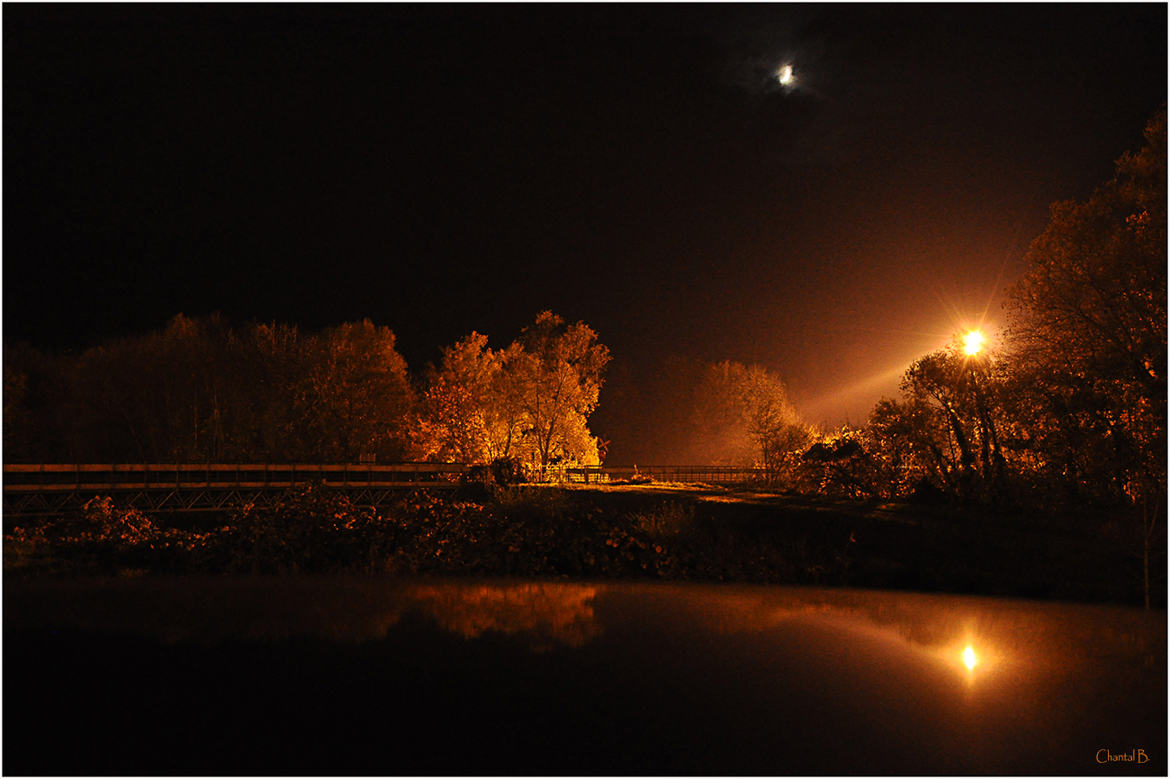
[4, 462, 764, 517]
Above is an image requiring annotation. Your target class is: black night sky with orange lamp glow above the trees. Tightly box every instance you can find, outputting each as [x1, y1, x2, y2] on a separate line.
[4, 4, 1166, 462]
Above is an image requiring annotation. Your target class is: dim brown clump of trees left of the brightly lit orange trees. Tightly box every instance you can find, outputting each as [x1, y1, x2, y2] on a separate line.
[12, 315, 413, 462]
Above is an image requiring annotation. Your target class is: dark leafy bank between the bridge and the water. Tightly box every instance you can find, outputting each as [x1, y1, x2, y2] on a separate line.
[4, 484, 1165, 607]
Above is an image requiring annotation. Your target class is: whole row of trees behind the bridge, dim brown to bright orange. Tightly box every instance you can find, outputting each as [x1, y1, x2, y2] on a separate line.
[4, 311, 610, 467]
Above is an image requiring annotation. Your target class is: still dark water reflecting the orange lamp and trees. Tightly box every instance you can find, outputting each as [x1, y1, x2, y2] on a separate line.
[2, 577, 1166, 777]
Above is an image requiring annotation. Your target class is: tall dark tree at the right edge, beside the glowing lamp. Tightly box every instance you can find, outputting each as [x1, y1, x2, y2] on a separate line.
[1009, 110, 1166, 605]
